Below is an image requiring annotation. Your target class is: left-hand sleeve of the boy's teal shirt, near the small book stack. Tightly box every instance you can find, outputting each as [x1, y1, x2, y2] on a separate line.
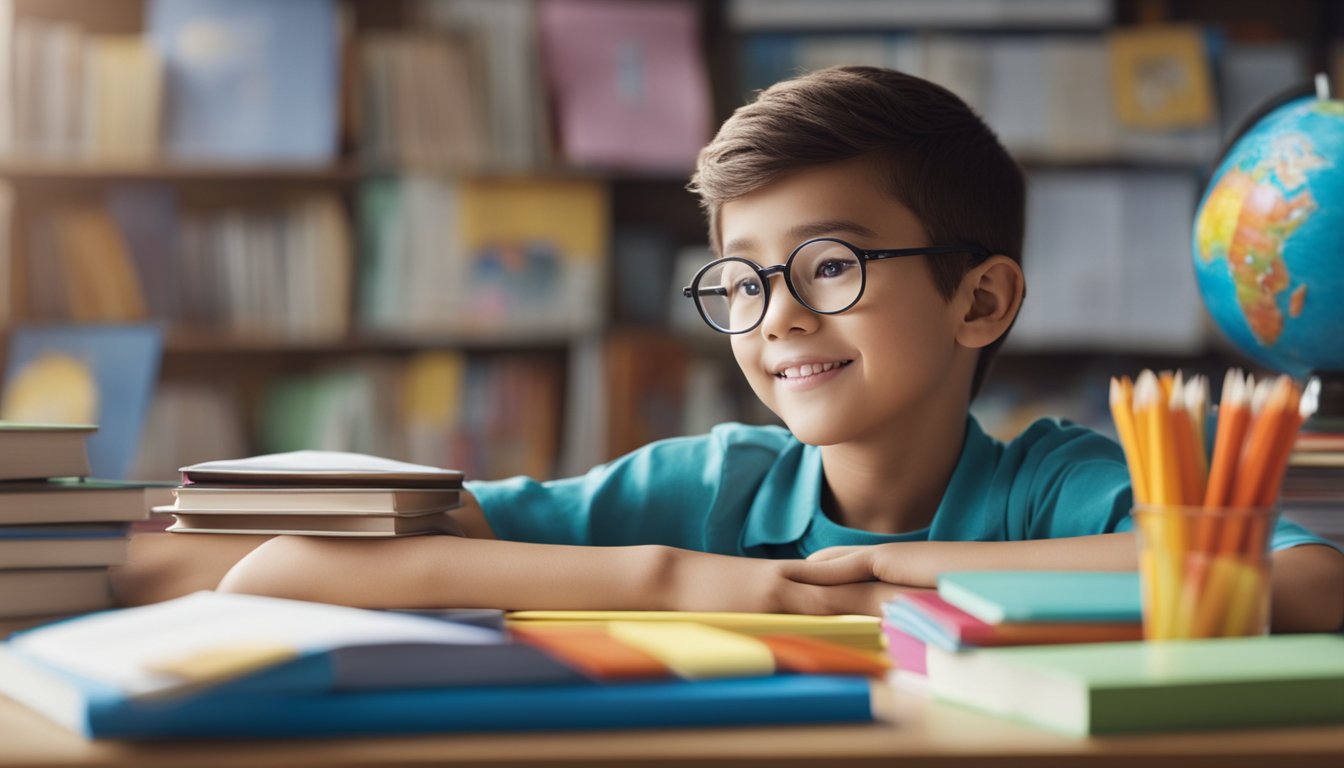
[465, 434, 723, 549]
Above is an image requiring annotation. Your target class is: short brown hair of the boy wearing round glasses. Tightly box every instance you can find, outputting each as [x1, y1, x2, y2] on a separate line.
[688, 66, 1025, 397]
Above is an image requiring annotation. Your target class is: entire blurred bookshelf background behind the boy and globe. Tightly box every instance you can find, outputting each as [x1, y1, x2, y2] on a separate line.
[0, 0, 1327, 479]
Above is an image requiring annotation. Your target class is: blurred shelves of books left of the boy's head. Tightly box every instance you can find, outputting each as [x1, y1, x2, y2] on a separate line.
[0, 0, 711, 479]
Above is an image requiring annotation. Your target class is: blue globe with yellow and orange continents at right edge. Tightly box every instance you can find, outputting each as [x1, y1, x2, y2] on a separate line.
[1193, 98, 1344, 377]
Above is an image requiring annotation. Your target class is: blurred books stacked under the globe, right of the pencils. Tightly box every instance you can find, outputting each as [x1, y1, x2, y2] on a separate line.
[1279, 428, 1344, 547]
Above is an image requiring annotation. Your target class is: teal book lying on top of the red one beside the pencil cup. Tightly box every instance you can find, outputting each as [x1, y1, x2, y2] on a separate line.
[938, 570, 1144, 624]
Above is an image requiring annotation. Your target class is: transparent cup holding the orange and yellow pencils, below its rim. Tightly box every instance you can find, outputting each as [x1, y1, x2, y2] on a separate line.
[1134, 504, 1278, 640]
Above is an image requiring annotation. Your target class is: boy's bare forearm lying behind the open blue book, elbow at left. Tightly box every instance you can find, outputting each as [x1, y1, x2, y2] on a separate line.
[219, 535, 900, 615]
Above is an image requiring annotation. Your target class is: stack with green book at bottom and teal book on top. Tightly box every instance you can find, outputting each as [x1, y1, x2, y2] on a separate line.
[884, 572, 1344, 736]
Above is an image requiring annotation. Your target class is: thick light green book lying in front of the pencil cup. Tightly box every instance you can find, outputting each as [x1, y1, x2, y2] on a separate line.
[927, 635, 1344, 736]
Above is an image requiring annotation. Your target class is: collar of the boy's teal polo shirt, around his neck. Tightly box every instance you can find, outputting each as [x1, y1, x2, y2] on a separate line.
[742, 416, 995, 554]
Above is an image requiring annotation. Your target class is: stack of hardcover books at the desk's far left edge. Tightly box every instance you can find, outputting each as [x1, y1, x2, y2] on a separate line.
[0, 422, 148, 620]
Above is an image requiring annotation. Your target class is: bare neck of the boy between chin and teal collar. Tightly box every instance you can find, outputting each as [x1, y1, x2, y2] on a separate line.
[821, 406, 968, 534]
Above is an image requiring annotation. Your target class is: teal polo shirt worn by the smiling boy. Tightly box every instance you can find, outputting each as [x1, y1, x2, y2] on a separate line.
[466, 417, 1324, 558]
